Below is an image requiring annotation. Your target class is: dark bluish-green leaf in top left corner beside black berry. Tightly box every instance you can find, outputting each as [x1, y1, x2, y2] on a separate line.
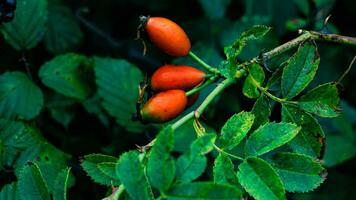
[1, 0, 48, 51]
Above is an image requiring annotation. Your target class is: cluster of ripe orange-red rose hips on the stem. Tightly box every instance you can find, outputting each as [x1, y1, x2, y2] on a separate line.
[140, 17, 206, 123]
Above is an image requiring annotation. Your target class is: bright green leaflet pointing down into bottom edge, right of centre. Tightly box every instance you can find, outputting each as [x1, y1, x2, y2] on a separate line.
[237, 157, 286, 200]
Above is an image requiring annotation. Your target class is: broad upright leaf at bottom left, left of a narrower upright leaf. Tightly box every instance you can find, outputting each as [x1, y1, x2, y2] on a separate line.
[18, 163, 51, 200]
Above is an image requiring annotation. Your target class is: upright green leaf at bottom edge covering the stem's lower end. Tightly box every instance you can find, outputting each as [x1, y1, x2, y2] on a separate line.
[116, 151, 153, 200]
